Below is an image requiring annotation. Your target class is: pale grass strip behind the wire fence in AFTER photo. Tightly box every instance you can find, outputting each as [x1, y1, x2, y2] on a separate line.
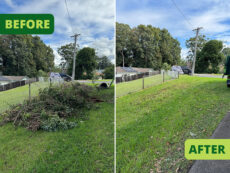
[116, 74, 177, 97]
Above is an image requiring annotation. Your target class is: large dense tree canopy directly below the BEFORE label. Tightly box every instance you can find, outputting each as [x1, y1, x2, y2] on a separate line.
[0, 35, 54, 77]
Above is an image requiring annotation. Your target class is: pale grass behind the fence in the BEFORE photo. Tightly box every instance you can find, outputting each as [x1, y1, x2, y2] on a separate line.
[0, 82, 49, 113]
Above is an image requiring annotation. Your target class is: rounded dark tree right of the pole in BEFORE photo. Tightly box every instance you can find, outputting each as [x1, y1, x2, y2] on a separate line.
[68, 47, 97, 79]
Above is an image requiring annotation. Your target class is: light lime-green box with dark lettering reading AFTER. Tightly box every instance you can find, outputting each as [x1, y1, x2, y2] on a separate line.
[185, 139, 230, 160]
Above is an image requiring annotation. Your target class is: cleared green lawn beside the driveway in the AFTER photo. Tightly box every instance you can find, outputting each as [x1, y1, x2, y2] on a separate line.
[116, 76, 230, 173]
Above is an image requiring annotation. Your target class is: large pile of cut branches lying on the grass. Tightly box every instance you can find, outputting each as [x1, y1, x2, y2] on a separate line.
[1, 83, 98, 131]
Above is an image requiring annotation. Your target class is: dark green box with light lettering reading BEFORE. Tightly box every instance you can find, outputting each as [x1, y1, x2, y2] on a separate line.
[0, 14, 54, 34]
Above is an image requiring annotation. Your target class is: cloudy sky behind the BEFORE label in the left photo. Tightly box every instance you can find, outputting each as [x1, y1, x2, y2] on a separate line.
[0, 0, 115, 65]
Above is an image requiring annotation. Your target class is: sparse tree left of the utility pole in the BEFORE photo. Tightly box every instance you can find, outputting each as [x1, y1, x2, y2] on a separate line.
[58, 43, 74, 69]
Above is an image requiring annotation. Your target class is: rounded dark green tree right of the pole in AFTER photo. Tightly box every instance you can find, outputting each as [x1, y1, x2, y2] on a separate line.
[196, 40, 224, 73]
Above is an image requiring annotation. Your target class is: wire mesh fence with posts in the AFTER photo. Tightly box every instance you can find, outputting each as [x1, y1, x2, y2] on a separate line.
[116, 70, 179, 97]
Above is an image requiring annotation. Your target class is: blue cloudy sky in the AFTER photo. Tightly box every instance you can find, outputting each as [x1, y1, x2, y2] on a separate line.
[116, 0, 230, 58]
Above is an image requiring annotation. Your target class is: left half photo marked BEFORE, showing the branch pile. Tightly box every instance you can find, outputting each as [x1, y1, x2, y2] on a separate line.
[0, 0, 115, 173]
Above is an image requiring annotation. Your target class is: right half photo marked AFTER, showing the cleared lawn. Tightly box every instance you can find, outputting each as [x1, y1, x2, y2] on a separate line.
[116, 0, 230, 173]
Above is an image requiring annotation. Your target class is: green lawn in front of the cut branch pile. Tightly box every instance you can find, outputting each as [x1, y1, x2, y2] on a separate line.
[0, 87, 114, 173]
